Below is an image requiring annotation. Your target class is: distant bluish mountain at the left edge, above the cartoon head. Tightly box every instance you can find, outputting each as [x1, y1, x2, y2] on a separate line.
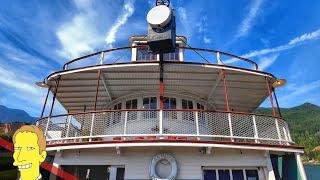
[0, 105, 37, 123]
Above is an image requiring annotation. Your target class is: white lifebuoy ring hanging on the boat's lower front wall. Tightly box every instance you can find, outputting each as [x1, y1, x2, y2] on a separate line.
[150, 153, 178, 180]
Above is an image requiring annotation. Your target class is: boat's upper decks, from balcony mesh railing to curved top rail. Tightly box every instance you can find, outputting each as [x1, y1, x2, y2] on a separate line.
[38, 37, 302, 153]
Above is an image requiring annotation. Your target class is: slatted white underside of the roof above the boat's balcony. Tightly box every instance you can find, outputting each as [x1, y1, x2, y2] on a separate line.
[48, 62, 275, 112]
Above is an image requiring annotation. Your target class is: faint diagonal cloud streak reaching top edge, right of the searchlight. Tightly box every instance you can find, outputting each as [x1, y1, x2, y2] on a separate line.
[235, 0, 262, 38]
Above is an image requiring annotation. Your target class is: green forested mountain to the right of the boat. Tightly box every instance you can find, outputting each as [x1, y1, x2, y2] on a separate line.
[256, 103, 320, 161]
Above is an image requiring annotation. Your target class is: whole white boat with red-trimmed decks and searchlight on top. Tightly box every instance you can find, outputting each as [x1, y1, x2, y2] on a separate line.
[37, 1, 306, 180]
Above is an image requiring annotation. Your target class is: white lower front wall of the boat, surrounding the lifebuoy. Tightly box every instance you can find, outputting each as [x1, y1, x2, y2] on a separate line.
[50, 147, 280, 180]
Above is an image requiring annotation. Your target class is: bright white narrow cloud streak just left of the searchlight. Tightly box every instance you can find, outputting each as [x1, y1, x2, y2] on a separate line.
[105, 0, 134, 47]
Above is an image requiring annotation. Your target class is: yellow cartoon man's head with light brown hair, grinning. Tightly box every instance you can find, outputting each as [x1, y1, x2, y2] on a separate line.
[13, 125, 47, 180]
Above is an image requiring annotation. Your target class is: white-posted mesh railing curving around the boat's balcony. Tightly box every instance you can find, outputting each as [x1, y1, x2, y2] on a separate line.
[37, 110, 293, 144]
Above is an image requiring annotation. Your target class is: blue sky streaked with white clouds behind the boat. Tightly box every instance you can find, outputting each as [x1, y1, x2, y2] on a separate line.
[0, 0, 320, 116]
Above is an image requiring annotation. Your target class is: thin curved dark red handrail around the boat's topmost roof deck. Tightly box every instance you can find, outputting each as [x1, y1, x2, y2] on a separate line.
[63, 45, 258, 70]
